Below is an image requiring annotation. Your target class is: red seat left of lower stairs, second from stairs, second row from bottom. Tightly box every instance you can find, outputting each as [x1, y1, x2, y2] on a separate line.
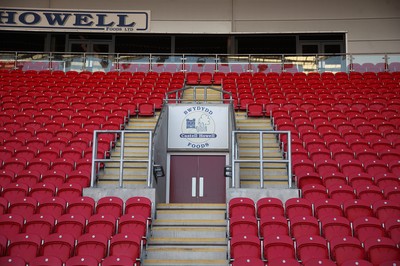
[75, 234, 108, 265]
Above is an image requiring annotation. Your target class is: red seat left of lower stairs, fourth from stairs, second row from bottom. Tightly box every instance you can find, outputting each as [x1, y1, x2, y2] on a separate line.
[7, 234, 42, 263]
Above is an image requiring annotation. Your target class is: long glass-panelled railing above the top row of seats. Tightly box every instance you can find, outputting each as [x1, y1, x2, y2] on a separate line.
[0, 52, 400, 73]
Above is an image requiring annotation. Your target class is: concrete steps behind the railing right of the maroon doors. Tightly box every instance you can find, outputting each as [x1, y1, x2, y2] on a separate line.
[235, 112, 288, 188]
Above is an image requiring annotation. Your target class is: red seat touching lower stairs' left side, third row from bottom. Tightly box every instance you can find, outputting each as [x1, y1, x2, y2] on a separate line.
[118, 214, 149, 238]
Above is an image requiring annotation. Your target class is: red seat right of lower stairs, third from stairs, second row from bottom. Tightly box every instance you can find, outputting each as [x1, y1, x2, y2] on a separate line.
[296, 235, 329, 264]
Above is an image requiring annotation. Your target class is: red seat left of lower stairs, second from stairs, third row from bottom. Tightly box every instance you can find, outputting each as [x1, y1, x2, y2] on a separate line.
[85, 214, 116, 238]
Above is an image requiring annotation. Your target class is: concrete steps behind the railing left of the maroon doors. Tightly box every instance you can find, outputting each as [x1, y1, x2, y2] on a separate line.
[97, 114, 158, 188]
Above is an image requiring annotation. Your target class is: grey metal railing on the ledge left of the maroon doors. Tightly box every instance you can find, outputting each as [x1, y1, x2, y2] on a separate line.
[90, 130, 153, 188]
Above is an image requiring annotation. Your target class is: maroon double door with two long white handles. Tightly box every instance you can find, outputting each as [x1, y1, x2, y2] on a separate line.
[170, 155, 226, 203]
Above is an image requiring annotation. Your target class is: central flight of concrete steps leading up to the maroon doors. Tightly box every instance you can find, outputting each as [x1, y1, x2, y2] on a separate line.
[143, 204, 228, 266]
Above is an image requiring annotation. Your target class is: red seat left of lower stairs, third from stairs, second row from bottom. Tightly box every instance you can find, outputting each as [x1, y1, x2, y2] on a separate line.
[41, 233, 75, 263]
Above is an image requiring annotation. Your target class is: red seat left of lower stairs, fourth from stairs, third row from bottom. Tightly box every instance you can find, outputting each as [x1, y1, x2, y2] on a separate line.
[22, 214, 55, 239]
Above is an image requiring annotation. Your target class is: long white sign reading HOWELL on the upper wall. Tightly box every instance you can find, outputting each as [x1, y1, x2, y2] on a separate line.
[0, 8, 150, 33]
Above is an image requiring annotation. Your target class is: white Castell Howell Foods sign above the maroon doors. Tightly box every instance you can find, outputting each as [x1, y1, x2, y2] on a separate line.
[168, 105, 229, 150]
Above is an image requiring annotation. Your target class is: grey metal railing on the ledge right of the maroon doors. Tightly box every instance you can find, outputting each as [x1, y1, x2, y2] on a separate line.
[231, 130, 292, 188]
